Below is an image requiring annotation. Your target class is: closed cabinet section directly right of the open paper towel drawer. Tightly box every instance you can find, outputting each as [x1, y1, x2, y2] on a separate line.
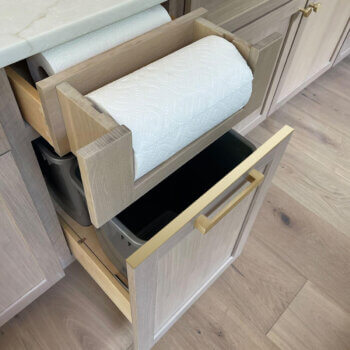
[186, 0, 307, 135]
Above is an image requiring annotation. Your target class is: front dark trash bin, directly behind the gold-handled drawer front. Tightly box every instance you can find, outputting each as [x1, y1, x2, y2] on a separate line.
[97, 131, 255, 276]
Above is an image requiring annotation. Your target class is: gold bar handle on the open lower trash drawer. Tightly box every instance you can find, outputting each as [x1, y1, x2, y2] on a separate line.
[194, 169, 264, 235]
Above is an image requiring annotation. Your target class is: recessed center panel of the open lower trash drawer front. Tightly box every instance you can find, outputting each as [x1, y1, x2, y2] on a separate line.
[154, 179, 255, 332]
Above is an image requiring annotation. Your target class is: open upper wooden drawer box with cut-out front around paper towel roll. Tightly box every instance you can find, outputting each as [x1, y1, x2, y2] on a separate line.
[8, 9, 281, 227]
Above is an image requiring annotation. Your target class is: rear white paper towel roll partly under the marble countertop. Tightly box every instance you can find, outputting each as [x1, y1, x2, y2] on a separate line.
[27, 5, 171, 82]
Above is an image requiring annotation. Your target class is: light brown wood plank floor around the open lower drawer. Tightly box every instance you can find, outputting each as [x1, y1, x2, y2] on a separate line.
[0, 58, 350, 350]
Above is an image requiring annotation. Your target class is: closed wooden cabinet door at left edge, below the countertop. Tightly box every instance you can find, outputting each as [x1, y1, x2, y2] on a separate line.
[0, 152, 64, 325]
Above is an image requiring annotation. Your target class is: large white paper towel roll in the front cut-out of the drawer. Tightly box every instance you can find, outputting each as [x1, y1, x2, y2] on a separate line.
[86, 36, 253, 179]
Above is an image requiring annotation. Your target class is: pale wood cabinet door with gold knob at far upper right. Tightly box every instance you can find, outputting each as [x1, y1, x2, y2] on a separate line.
[272, 0, 350, 111]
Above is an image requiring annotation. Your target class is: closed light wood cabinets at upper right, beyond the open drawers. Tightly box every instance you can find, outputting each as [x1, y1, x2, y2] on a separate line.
[186, 0, 350, 119]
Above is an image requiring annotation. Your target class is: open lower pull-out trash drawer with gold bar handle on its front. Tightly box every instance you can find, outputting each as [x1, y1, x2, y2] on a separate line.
[58, 126, 293, 349]
